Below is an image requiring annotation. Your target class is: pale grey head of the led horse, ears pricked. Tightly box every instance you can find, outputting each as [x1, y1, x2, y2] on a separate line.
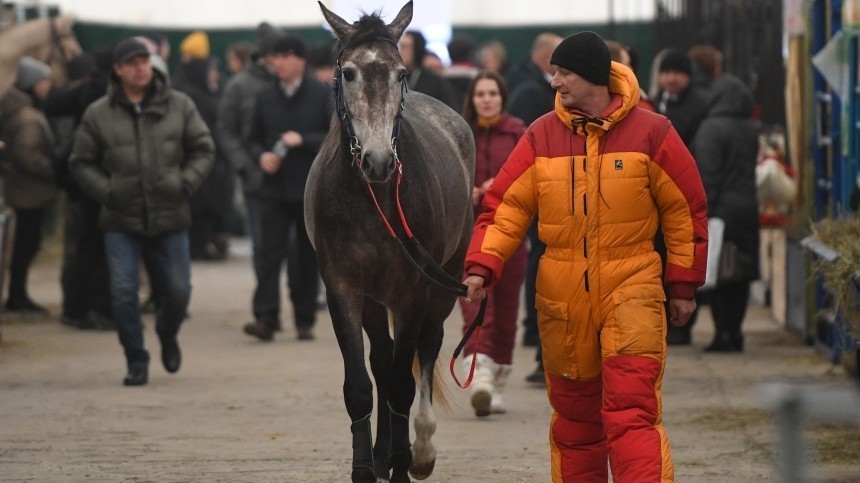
[320, 1, 412, 182]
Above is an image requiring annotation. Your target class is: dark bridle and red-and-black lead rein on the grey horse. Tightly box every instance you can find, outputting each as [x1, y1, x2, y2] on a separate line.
[331, 37, 487, 388]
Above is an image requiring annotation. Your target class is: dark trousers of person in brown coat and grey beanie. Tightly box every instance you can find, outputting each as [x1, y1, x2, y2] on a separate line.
[9, 208, 45, 300]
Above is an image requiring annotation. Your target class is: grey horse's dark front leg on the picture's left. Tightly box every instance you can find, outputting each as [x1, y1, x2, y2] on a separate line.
[327, 289, 377, 483]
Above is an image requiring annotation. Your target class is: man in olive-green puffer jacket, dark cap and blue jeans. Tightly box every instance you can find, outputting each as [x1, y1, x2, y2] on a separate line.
[70, 39, 215, 386]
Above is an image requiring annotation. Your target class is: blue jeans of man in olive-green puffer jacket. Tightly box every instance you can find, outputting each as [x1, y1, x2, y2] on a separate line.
[105, 231, 191, 367]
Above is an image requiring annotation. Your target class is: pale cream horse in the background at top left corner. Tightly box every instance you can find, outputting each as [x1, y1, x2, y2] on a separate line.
[0, 15, 82, 97]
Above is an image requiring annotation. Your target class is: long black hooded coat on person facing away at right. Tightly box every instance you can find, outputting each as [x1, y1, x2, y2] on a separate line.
[692, 74, 759, 280]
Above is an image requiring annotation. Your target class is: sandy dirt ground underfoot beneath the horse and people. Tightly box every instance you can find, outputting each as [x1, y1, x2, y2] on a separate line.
[0, 240, 860, 483]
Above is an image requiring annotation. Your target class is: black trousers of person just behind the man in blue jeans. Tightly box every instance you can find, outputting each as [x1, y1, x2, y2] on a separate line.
[60, 197, 111, 319]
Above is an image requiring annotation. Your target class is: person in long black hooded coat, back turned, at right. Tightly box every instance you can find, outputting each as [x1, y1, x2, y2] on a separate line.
[692, 74, 759, 352]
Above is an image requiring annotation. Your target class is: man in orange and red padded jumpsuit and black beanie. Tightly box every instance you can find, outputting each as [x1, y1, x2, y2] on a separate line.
[464, 32, 708, 483]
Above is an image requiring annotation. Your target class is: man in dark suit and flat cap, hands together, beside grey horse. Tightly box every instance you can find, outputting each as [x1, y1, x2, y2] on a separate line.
[244, 35, 331, 341]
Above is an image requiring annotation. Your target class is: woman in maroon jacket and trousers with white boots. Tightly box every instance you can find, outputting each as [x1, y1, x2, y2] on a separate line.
[460, 70, 528, 417]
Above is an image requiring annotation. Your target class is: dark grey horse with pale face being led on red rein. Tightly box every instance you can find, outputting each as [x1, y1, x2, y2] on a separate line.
[305, 1, 475, 482]
